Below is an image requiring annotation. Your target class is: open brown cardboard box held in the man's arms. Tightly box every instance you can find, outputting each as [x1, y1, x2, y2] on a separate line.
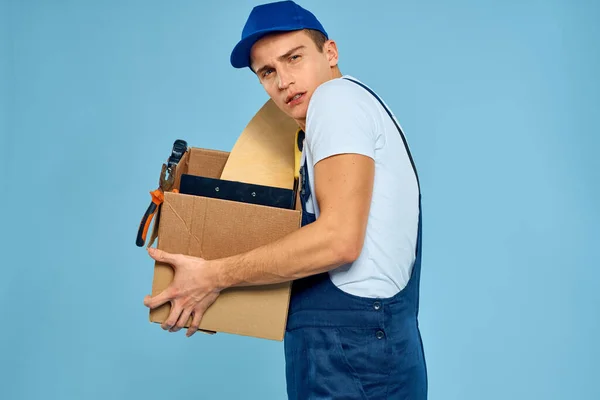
[150, 147, 301, 341]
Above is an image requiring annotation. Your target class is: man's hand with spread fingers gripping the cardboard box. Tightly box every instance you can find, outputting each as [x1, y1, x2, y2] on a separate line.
[144, 248, 220, 337]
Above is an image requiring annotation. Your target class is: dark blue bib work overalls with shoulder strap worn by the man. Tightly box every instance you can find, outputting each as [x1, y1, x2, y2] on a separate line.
[284, 78, 427, 400]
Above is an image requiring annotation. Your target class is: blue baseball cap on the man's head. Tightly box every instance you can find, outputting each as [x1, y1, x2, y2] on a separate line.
[231, 0, 329, 68]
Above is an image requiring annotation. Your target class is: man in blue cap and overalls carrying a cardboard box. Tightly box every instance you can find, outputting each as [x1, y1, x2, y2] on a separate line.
[145, 1, 427, 400]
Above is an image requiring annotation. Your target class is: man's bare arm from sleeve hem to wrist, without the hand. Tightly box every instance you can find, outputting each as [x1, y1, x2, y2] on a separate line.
[209, 154, 375, 290]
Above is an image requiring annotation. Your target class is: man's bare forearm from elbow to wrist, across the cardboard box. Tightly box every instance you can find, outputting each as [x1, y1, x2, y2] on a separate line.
[212, 220, 359, 289]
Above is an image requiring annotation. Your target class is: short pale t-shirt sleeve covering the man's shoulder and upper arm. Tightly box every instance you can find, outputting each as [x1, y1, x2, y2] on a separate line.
[306, 81, 376, 165]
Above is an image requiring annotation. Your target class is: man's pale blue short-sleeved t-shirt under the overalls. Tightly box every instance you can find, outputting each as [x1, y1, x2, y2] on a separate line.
[302, 75, 419, 298]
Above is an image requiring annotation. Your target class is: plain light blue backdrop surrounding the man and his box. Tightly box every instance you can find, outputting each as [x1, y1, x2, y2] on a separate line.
[0, 0, 600, 400]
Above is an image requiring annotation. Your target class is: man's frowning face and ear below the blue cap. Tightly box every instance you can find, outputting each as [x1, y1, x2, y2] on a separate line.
[251, 31, 339, 128]
